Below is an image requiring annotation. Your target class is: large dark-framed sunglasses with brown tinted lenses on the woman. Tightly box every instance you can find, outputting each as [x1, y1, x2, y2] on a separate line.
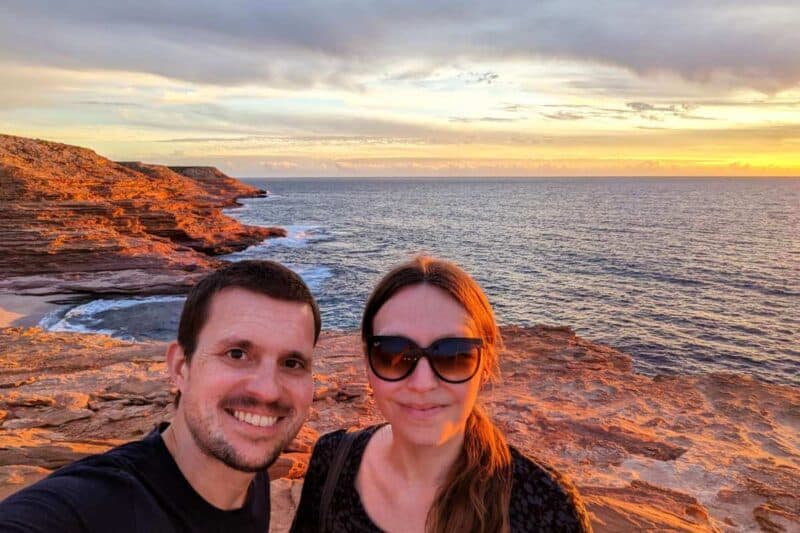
[367, 335, 483, 383]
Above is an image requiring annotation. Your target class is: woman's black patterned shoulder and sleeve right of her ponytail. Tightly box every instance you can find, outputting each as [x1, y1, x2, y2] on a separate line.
[509, 446, 592, 532]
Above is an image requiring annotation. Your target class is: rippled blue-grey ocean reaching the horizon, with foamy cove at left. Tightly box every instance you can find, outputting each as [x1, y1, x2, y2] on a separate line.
[42, 178, 800, 385]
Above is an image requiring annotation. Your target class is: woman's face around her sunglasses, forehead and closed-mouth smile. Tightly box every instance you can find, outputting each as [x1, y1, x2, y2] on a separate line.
[367, 284, 481, 445]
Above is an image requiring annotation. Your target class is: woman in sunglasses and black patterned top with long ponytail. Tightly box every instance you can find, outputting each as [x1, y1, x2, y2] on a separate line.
[292, 257, 591, 533]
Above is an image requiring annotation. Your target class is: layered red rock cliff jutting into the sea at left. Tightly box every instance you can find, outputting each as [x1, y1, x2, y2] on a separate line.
[0, 135, 284, 294]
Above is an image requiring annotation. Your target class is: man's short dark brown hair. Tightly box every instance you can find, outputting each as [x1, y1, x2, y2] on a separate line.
[178, 260, 322, 361]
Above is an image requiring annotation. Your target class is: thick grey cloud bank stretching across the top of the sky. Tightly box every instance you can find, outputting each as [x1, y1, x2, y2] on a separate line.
[0, 0, 800, 92]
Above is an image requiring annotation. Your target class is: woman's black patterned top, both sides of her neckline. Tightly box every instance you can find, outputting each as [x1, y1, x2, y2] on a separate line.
[291, 425, 592, 533]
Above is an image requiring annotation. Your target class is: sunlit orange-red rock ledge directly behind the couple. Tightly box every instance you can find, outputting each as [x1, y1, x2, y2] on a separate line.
[0, 327, 800, 532]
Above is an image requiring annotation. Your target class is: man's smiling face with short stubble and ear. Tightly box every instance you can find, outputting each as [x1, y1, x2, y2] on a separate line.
[175, 288, 314, 472]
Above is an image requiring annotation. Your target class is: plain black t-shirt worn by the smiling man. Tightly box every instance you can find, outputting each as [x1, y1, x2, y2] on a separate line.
[0, 424, 269, 533]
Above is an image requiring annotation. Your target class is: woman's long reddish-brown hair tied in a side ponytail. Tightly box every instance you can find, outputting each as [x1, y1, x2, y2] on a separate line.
[361, 256, 512, 533]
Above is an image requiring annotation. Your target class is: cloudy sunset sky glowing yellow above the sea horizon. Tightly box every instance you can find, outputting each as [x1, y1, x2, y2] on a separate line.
[0, 0, 800, 177]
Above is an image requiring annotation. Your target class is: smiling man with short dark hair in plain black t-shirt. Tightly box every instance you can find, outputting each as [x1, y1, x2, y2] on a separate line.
[0, 261, 320, 533]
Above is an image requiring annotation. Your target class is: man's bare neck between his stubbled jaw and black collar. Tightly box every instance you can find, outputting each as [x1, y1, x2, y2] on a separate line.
[161, 414, 255, 511]
